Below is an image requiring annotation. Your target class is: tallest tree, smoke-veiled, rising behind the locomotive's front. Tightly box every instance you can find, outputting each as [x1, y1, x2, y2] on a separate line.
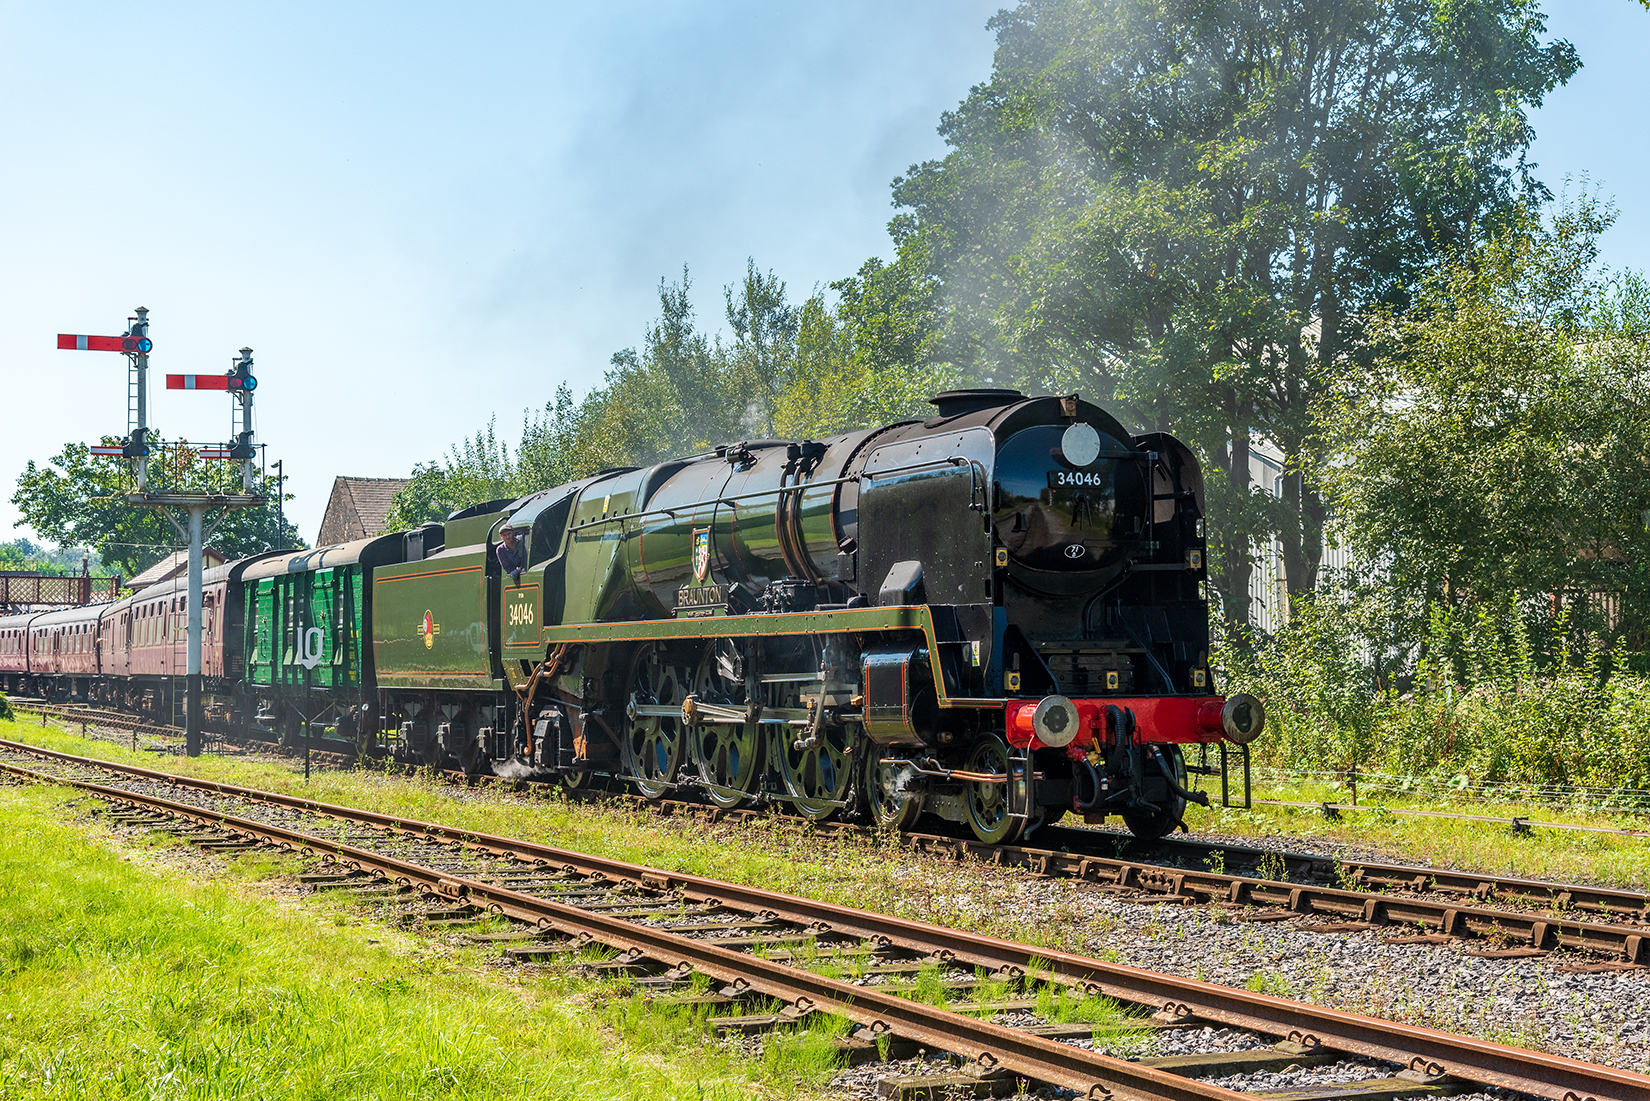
[891, 0, 1579, 622]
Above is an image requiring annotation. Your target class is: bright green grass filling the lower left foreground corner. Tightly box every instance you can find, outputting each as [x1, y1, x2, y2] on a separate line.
[0, 786, 833, 1101]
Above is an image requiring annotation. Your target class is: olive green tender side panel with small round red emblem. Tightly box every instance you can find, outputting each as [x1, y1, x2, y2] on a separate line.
[373, 543, 503, 690]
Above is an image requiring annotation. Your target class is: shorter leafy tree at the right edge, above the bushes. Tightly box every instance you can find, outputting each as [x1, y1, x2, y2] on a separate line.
[1322, 200, 1650, 647]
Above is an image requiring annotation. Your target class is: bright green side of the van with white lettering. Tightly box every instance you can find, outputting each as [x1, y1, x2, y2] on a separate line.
[246, 566, 361, 690]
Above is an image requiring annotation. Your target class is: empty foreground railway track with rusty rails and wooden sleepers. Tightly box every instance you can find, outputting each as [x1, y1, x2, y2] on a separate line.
[0, 743, 1650, 1101]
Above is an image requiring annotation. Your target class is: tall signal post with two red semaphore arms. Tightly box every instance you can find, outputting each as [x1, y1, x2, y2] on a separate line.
[58, 305, 269, 756]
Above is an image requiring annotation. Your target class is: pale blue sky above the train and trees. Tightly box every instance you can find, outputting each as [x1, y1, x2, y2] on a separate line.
[0, 0, 1650, 540]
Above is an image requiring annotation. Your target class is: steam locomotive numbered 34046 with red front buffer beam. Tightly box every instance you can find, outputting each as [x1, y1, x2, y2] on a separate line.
[396, 382, 1264, 842]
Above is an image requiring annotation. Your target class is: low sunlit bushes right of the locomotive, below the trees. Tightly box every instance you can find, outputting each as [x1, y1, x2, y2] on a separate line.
[1224, 589, 1650, 804]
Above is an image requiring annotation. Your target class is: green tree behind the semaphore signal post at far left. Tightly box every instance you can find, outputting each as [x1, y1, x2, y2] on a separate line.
[12, 437, 305, 576]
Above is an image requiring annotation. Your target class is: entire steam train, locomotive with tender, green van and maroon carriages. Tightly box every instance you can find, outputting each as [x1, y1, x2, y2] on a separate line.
[0, 390, 1264, 843]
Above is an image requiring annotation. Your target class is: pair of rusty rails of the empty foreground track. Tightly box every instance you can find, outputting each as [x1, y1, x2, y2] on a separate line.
[0, 741, 1650, 1101]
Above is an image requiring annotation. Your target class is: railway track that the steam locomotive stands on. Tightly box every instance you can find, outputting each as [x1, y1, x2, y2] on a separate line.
[0, 705, 1650, 971]
